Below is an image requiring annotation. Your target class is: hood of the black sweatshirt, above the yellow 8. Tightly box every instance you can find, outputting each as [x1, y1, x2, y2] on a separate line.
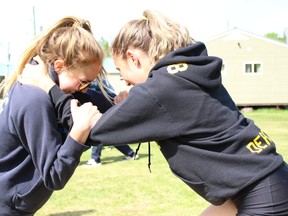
[152, 42, 222, 90]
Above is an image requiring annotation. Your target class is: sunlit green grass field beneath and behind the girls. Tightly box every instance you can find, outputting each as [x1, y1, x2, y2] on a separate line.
[36, 109, 288, 216]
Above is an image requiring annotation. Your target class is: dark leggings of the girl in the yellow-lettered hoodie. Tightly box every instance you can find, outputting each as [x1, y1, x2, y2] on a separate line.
[232, 164, 288, 216]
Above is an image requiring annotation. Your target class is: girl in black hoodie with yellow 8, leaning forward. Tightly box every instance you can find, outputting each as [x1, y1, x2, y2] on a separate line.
[18, 10, 288, 216]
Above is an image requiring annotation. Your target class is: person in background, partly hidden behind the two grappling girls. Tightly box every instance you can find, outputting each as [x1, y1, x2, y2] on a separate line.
[73, 78, 139, 167]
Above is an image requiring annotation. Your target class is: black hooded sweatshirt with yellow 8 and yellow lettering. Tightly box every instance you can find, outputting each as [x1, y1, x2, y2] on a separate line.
[50, 42, 283, 205]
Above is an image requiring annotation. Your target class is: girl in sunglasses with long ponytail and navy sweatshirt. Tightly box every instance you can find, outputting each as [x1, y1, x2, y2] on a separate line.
[0, 17, 104, 216]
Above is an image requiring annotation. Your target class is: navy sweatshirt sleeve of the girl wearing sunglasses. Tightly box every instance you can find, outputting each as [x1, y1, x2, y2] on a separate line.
[10, 85, 88, 190]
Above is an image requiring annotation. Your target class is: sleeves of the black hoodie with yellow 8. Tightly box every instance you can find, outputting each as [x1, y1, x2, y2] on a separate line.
[50, 85, 177, 145]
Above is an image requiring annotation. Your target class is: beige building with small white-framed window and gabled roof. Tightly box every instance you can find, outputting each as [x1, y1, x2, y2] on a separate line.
[205, 29, 288, 106]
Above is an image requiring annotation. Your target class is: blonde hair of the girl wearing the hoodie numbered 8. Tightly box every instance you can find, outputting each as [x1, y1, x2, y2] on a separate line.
[111, 10, 195, 64]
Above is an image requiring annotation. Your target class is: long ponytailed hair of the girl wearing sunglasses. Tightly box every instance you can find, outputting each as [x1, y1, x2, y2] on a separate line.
[1, 16, 106, 95]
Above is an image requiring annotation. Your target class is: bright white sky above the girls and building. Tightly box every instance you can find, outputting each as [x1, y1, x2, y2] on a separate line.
[0, 0, 288, 64]
